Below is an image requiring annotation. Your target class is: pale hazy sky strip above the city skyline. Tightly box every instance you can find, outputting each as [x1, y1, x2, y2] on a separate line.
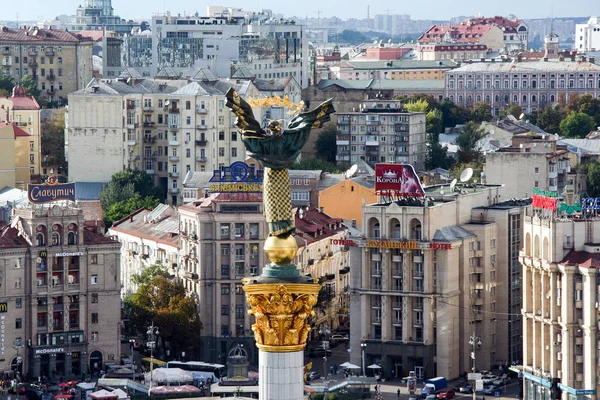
[0, 0, 600, 21]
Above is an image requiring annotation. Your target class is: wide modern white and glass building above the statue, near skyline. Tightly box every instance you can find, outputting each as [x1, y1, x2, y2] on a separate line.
[152, 10, 308, 88]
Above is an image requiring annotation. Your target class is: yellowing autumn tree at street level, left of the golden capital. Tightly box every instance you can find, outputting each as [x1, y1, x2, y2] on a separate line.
[125, 274, 202, 354]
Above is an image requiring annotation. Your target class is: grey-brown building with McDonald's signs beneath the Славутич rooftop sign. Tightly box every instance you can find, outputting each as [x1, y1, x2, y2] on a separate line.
[0, 204, 121, 380]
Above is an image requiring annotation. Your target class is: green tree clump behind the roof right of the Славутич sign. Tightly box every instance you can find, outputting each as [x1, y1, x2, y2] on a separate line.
[100, 170, 166, 227]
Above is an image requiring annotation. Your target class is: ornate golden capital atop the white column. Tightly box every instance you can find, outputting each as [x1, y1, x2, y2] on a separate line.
[244, 282, 321, 353]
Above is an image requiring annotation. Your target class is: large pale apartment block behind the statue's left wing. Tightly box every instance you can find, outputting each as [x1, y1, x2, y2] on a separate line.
[66, 77, 260, 205]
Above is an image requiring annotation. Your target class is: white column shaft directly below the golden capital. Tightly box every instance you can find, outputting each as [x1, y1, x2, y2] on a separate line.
[258, 350, 304, 400]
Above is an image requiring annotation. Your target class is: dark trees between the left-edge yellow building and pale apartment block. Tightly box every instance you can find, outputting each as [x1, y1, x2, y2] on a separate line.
[41, 108, 67, 173]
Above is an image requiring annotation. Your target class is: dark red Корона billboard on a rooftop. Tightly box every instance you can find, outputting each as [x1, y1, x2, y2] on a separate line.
[375, 164, 425, 197]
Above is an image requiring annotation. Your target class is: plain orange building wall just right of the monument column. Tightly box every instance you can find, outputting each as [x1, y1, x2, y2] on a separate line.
[319, 176, 377, 227]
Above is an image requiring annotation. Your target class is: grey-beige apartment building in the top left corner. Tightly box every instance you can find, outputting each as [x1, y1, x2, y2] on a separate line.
[0, 26, 92, 105]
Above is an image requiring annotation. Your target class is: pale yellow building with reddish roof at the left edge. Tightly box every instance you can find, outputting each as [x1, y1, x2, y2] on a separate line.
[0, 86, 41, 189]
